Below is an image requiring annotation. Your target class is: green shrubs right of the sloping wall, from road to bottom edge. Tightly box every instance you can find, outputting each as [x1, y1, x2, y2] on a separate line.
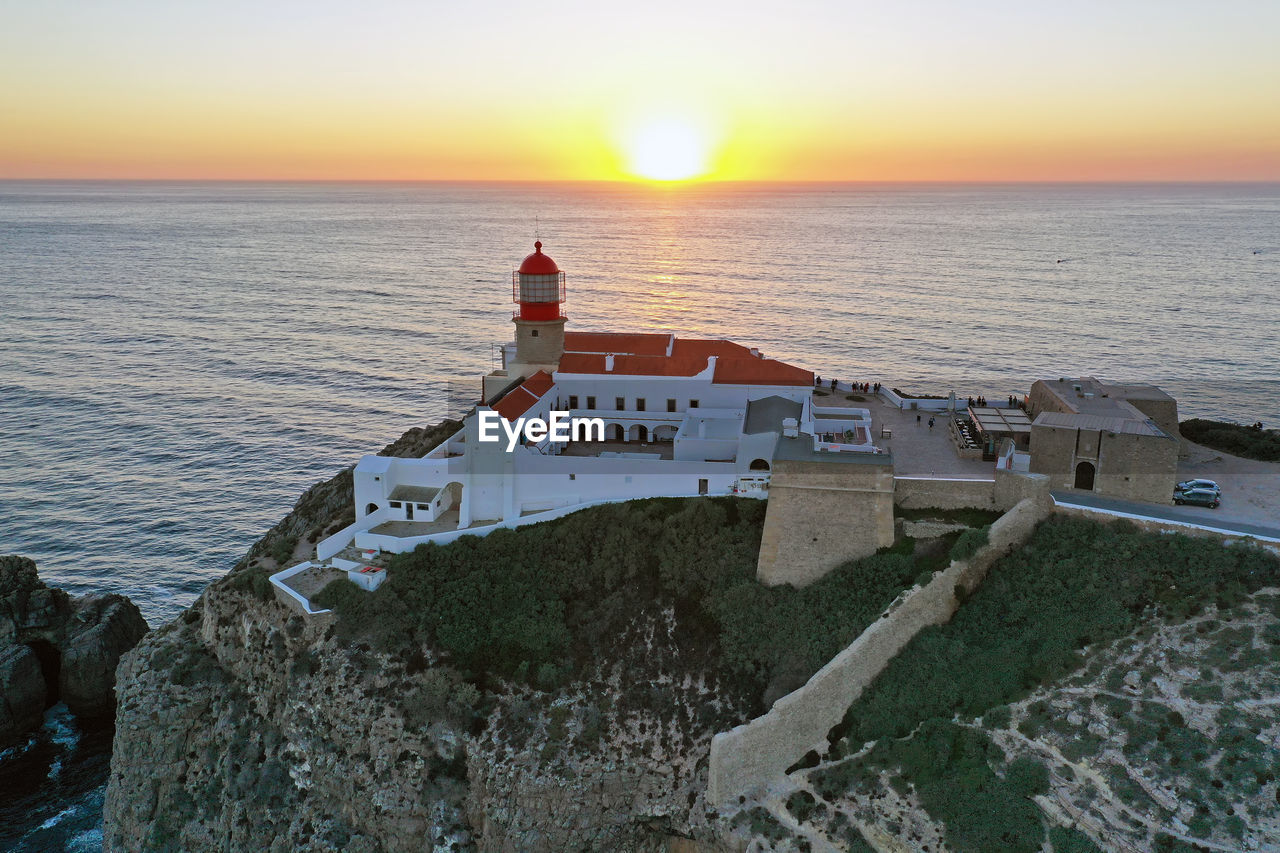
[813, 517, 1280, 852]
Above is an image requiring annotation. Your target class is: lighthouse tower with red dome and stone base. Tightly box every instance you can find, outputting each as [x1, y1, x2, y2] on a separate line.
[507, 241, 564, 375]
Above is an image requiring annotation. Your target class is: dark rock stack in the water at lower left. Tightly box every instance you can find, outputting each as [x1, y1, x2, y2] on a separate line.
[0, 556, 147, 744]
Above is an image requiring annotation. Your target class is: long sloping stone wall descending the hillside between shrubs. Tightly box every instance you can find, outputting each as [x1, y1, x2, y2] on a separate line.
[707, 494, 1050, 804]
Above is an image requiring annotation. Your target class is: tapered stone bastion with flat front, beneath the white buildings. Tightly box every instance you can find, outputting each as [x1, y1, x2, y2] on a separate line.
[756, 457, 893, 587]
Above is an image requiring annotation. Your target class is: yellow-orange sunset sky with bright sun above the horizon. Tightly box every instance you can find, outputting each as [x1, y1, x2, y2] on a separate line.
[0, 0, 1280, 181]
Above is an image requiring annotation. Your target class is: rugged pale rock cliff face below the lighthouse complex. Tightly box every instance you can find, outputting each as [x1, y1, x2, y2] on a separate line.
[104, 427, 749, 852]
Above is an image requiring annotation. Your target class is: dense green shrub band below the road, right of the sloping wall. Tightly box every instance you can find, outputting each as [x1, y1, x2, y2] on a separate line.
[846, 516, 1280, 743]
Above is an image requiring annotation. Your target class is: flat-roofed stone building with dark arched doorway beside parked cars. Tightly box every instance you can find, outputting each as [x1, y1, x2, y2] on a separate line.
[1028, 377, 1179, 503]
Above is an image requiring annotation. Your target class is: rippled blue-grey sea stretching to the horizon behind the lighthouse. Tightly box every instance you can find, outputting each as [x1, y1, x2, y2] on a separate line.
[0, 182, 1280, 850]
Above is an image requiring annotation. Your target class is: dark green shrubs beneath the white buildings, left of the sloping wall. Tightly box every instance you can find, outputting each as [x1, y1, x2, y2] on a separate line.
[316, 498, 952, 701]
